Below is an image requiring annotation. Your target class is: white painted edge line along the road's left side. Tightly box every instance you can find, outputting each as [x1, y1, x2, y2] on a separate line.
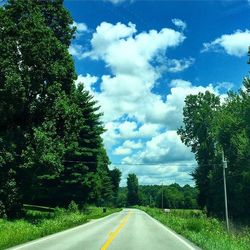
[9, 210, 123, 250]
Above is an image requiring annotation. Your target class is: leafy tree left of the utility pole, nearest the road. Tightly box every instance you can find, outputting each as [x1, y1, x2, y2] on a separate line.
[178, 91, 220, 212]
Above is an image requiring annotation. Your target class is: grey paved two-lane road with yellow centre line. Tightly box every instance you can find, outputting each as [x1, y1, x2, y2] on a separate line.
[11, 209, 198, 250]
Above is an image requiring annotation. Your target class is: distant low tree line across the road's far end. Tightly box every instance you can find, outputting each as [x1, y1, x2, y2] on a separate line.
[117, 174, 198, 209]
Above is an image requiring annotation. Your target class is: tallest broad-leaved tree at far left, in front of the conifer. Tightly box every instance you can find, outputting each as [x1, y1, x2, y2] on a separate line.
[0, 0, 76, 215]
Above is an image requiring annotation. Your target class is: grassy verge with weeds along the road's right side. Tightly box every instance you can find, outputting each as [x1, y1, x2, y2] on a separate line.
[137, 207, 250, 250]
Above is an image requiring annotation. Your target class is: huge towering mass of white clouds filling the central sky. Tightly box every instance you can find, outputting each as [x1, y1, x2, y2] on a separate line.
[73, 22, 219, 184]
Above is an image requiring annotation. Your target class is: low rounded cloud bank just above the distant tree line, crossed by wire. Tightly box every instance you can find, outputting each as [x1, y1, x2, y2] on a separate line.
[119, 131, 196, 185]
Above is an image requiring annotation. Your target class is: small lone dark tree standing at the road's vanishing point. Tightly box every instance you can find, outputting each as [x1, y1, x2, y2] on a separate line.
[127, 174, 139, 206]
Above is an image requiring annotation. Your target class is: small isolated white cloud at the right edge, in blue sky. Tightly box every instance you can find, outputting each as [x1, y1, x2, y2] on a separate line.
[202, 29, 250, 57]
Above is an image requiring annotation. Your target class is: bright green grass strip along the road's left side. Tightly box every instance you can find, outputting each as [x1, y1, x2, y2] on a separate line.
[0, 207, 121, 250]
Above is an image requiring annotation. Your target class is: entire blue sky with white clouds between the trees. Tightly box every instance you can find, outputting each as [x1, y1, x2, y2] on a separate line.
[64, 0, 250, 185]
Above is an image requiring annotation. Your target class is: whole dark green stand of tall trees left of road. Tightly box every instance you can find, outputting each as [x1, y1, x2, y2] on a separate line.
[0, 0, 121, 218]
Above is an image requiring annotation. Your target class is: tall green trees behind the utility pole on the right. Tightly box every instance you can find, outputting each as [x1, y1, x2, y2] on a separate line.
[178, 53, 250, 219]
